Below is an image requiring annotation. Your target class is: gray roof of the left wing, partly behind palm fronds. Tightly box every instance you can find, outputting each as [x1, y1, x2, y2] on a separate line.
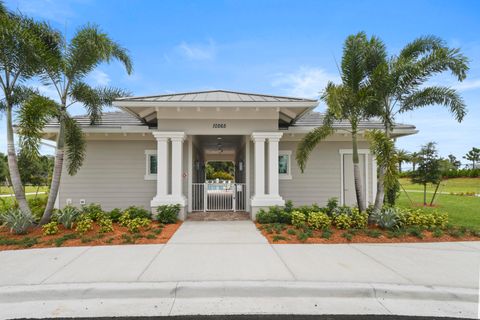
[45, 111, 145, 128]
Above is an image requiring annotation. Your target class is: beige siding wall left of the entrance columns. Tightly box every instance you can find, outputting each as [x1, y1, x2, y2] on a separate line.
[60, 140, 157, 210]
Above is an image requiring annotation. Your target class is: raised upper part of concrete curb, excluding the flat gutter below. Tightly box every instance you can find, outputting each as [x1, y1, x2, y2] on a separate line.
[0, 281, 478, 303]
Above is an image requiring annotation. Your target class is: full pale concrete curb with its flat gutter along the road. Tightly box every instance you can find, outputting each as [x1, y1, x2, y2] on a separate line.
[0, 281, 478, 319]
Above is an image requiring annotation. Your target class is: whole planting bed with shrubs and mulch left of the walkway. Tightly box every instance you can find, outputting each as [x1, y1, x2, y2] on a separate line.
[0, 204, 181, 250]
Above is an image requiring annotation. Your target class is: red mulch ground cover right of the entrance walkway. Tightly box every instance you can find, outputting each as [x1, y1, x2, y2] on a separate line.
[256, 223, 480, 244]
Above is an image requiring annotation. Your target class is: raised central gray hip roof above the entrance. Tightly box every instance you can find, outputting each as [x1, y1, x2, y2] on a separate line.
[117, 90, 316, 102]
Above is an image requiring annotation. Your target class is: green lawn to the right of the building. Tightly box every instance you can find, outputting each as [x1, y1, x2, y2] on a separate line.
[397, 188, 480, 229]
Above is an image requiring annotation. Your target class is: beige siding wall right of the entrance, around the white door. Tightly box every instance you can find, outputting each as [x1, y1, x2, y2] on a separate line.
[280, 141, 373, 205]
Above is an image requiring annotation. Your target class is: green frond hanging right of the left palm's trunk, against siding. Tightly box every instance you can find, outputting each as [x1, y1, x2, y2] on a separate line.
[65, 117, 85, 176]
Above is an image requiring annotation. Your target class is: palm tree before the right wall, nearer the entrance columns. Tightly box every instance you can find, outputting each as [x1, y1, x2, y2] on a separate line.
[296, 32, 382, 211]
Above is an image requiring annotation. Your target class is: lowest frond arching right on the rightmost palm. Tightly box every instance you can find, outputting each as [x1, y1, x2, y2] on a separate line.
[399, 86, 467, 122]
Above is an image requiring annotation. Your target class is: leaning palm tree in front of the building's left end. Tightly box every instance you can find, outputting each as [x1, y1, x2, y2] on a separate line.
[19, 25, 132, 224]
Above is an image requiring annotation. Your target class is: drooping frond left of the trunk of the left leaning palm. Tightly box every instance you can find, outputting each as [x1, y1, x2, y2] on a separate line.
[17, 95, 57, 159]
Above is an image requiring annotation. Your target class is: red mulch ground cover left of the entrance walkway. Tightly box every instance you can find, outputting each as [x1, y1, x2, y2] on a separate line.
[0, 222, 182, 251]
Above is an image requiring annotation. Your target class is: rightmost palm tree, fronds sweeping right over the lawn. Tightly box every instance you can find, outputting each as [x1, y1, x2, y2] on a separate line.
[370, 36, 468, 210]
